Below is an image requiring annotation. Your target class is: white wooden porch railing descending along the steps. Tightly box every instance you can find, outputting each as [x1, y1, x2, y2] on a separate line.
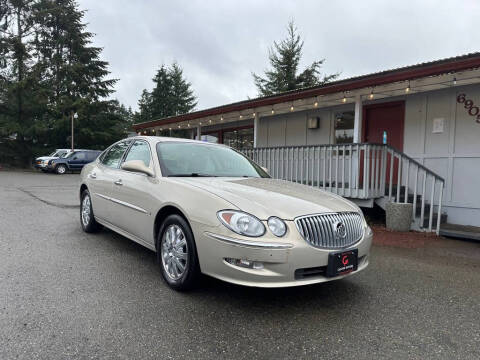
[241, 143, 445, 234]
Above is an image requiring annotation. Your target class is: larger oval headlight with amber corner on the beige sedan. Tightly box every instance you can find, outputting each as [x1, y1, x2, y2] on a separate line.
[217, 210, 265, 237]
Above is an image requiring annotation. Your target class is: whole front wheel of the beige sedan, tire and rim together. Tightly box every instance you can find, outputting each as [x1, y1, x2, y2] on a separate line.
[157, 215, 200, 291]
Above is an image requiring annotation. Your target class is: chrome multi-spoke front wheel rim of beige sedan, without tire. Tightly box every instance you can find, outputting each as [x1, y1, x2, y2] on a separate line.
[161, 224, 188, 280]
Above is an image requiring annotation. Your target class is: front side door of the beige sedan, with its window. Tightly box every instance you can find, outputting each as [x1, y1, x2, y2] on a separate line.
[112, 140, 158, 246]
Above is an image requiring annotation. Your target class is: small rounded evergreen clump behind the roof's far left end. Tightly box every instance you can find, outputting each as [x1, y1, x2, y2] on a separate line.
[135, 63, 197, 123]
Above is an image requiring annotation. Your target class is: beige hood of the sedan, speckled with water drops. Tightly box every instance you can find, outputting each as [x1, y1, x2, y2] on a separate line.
[175, 177, 359, 220]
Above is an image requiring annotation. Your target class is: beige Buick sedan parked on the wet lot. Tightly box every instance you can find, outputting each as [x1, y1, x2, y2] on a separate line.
[80, 136, 372, 290]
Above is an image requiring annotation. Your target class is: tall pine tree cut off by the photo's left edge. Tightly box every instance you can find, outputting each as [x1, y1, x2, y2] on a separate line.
[0, 0, 46, 164]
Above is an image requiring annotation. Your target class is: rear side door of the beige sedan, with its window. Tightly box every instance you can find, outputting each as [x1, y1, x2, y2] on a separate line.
[88, 140, 131, 225]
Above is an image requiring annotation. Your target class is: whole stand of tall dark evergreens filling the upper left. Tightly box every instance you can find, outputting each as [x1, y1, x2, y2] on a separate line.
[0, 0, 132, 164]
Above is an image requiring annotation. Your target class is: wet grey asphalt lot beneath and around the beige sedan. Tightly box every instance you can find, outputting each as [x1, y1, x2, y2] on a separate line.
[0, 171, 480, 360]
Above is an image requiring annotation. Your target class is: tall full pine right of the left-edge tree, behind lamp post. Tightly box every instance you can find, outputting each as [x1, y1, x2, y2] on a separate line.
[35, 0, 117, 148]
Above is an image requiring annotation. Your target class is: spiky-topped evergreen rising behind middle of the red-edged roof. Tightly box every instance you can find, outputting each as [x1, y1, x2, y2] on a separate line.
[253, 22, 339, 96]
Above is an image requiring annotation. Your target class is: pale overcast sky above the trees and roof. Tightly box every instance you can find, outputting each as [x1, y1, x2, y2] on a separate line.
[79, 0, 480, 110]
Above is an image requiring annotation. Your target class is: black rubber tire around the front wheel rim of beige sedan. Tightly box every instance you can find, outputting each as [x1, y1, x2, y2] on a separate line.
[156, 214, 200, 290]
